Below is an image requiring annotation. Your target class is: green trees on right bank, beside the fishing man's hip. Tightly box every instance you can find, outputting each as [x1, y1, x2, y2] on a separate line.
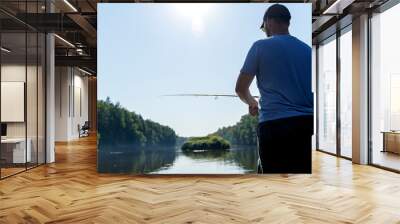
[215, 115, 258, 145]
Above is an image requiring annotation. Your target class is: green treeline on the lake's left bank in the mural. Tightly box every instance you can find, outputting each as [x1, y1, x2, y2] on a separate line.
[97, 97, 177, 147]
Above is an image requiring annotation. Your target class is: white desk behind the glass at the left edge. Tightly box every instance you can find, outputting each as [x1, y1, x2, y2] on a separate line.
[1, 138, 32, 163]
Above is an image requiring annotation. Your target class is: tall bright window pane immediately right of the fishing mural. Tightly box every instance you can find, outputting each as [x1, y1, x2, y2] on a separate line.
[317, 36, 337, 153]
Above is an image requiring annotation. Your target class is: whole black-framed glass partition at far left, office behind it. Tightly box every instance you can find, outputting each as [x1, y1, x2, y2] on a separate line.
[0, 1, 46, 179]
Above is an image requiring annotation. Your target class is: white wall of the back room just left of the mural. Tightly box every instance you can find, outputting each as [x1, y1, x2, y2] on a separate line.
[55, 67, 88, 141]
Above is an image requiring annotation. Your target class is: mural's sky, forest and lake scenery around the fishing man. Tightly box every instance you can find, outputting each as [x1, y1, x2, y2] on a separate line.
[97, 3, 311, 174]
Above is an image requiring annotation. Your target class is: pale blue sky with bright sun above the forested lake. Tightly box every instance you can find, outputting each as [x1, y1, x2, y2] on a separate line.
[97, 3, 311, 136]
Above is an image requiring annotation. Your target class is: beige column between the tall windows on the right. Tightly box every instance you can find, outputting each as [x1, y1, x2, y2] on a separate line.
[352, 15, 368, 164]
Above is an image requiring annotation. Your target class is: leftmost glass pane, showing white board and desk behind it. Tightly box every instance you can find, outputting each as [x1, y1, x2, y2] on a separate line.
[0, 32, 27, 177]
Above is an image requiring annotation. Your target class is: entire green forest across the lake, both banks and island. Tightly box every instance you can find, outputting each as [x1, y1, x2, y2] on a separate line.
[97, 97, 258, 151]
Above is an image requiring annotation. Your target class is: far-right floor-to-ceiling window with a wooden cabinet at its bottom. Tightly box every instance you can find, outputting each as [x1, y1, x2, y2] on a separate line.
[370, 4, 400, 170]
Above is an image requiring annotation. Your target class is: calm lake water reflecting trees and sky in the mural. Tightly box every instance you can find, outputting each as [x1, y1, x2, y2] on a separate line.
[98, 145, 258, 174]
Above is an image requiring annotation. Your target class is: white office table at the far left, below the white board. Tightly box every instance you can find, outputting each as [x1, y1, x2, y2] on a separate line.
[1, 138, 32, 163]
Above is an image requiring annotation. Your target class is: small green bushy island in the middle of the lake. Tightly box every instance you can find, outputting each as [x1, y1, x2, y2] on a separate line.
[181, 135, 231, 152]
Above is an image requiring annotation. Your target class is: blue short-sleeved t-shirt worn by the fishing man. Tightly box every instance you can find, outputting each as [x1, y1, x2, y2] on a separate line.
[241, 35, 313, 122]
